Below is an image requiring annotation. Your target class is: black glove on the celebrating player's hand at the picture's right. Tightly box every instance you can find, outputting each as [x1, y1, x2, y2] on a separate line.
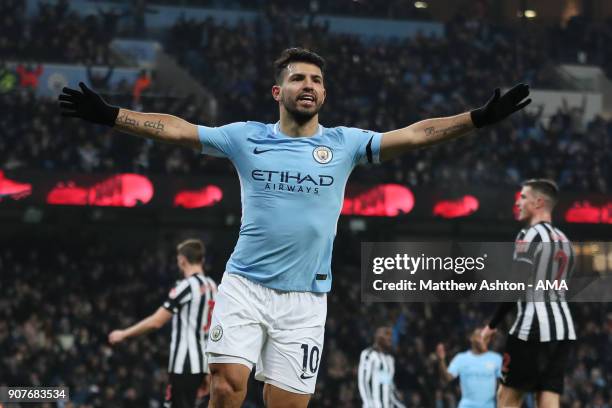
[470, 84, 531, 128]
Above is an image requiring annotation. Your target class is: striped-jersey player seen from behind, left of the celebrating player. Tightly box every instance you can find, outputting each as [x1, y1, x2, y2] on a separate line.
[108, 239, 217, 408]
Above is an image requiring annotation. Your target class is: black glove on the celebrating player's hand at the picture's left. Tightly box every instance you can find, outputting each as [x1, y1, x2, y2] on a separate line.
[57, 82, 119, 127]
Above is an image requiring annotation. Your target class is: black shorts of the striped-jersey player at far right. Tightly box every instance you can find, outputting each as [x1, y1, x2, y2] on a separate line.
[501, 336, 573, 394]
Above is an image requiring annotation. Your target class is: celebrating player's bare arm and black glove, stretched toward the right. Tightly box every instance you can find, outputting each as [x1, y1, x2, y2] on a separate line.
[380, 84, 531, 160]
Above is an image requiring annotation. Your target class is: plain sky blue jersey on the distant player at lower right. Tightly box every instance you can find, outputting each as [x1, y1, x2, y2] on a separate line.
[448, 350, 502, 408]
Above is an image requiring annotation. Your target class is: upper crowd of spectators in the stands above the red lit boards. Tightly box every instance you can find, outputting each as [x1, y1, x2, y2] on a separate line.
[0, 1, 612, 192]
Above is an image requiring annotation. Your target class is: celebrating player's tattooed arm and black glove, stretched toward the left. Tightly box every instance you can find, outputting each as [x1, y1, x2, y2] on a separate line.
[58, 82, 201, 149]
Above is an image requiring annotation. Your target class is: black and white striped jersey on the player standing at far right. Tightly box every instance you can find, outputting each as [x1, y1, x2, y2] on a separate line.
[510, 222, 576, 342]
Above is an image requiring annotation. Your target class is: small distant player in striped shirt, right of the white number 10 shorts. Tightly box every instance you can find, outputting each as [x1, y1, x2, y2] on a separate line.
[357, 326, 404, 408]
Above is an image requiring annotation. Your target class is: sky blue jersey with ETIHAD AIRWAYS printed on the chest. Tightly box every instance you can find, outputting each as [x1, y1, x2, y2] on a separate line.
[198, 122, 381, 292]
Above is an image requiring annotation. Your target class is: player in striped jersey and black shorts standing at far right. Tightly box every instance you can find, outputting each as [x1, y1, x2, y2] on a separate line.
[482, 179, 576, 408]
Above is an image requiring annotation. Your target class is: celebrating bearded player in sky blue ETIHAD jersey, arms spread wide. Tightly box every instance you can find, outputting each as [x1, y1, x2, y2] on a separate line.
[58, 48, 531, 407]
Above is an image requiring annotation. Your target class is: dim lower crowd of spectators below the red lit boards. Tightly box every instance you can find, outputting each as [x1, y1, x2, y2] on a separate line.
[0, 234, 612, 408]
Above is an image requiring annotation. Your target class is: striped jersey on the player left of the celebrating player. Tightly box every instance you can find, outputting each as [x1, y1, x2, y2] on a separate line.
[163, 274, 217, 374]
